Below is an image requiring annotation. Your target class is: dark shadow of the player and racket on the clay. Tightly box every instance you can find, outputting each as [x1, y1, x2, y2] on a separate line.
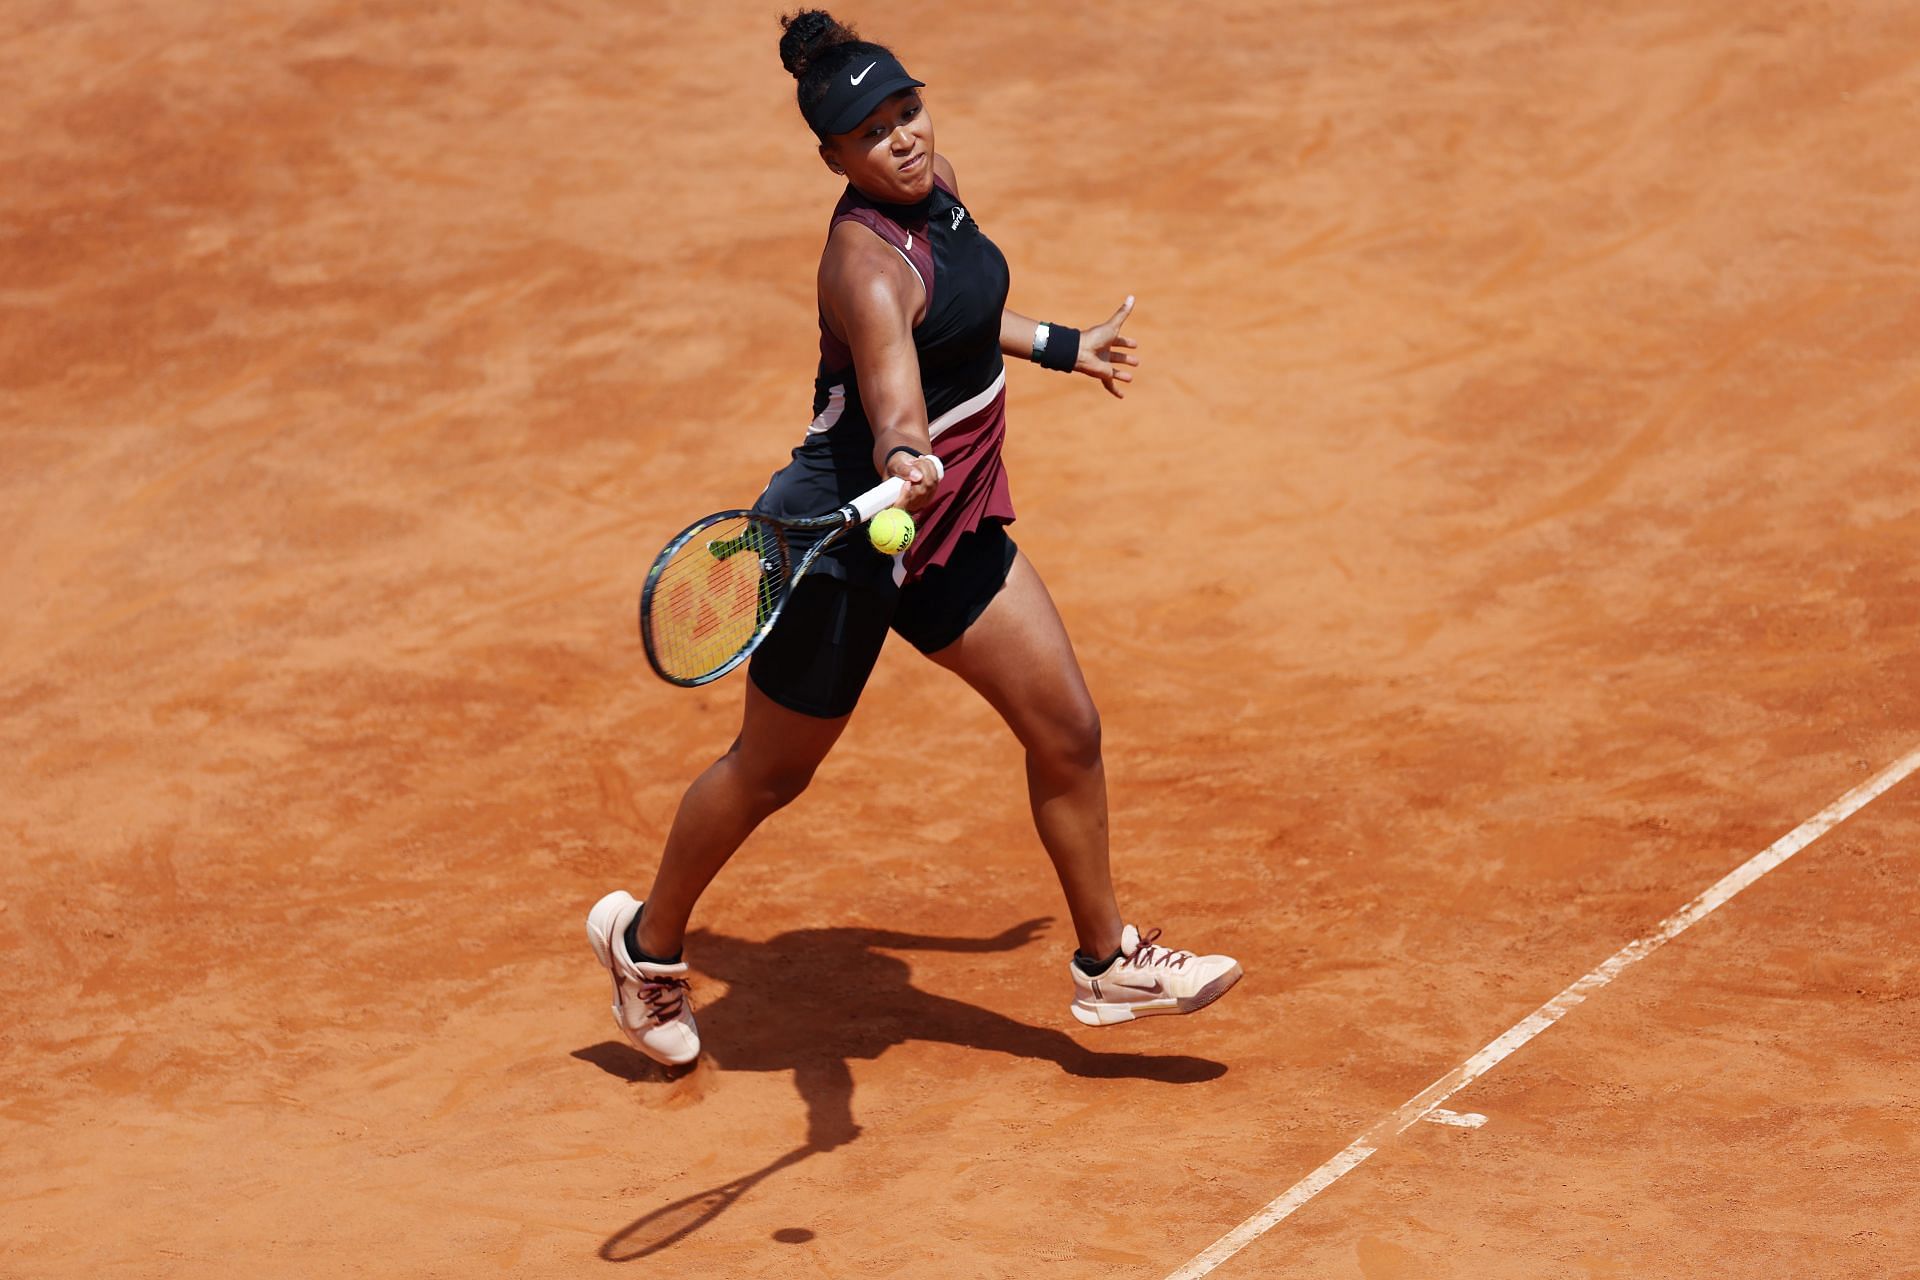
[574, 919, 1227, 1263]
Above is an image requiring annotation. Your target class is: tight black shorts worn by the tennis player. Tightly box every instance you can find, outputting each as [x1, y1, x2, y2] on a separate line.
[747, 520, 1020, 720]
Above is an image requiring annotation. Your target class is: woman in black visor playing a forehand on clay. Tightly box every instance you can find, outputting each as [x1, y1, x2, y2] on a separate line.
[588, 10, 1240, 1065]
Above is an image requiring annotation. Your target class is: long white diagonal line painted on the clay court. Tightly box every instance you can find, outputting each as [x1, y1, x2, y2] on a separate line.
[1167, 747, 1920, 1280]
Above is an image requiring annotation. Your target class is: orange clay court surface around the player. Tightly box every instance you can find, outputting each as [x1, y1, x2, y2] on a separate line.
[0, 0, 1920, 1280]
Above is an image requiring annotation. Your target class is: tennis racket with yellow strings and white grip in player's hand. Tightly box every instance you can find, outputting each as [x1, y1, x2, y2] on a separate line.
[639, 474, 910, 689]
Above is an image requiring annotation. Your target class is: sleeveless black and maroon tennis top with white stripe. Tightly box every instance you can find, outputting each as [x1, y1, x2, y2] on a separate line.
[756, 177, 1014, 581]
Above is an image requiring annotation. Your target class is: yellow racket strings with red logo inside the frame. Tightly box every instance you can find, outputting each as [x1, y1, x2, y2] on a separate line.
[649, 516, 789, 679]
